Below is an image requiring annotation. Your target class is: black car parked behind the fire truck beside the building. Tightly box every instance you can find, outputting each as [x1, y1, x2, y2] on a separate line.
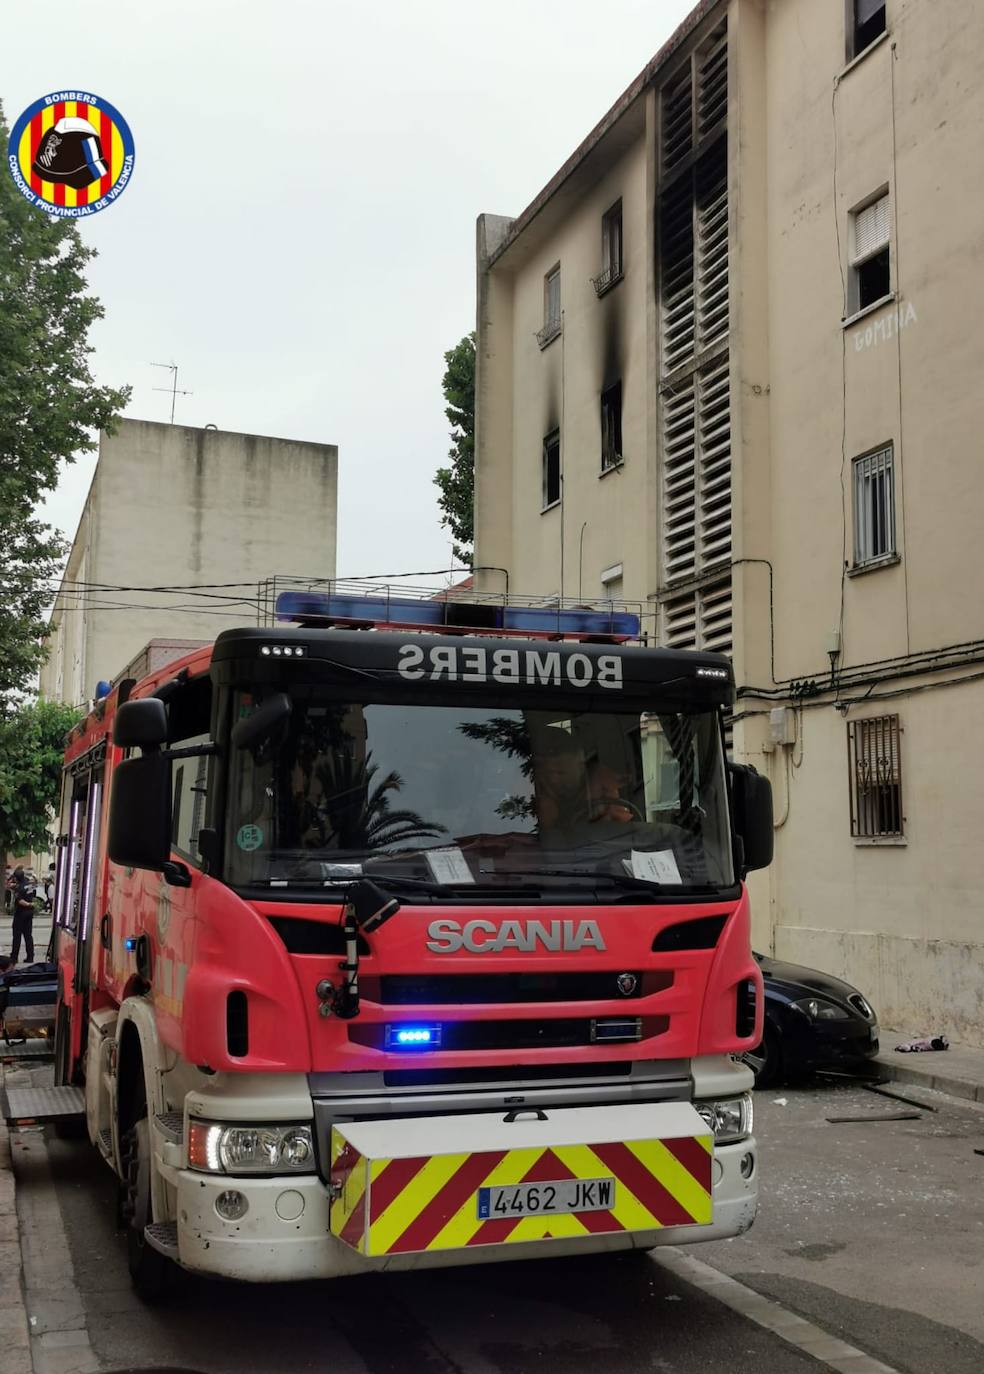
[743, 954, 878, 1088]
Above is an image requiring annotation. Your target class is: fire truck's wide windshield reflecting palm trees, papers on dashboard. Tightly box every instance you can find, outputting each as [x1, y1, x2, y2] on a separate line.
[225, 690, 734, 890]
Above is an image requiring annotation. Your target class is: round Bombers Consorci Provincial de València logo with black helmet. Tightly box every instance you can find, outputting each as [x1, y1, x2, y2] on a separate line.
[7, 91, 133, 220]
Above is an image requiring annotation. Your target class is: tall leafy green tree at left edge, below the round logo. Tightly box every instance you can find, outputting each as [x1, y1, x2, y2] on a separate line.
[0, 101, 129, 719]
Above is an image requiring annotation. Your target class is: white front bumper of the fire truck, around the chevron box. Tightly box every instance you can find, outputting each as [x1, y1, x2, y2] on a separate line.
[168, 1136, 759, 1283]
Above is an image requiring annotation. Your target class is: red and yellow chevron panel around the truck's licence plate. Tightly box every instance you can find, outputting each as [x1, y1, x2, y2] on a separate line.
[331, 1128, 712, 1254]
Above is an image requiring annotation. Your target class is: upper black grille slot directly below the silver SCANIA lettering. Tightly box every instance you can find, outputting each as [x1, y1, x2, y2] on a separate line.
[359, 969, 673, 1007]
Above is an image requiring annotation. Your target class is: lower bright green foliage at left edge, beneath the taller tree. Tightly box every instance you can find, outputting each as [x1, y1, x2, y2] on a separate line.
[0, 701, 82, 853]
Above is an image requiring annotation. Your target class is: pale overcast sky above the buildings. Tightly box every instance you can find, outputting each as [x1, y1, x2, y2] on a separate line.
[0, 0, 691, 576]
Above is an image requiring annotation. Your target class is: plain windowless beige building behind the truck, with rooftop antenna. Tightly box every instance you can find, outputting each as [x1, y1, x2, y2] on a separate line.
[40, 419, 338, 703]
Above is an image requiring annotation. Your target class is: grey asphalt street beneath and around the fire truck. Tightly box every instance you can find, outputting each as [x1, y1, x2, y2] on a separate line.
[7, 1071, 984, 1374]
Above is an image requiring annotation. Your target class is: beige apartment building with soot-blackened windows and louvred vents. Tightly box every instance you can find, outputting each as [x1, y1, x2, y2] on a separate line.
[476, 0, 984, 1043]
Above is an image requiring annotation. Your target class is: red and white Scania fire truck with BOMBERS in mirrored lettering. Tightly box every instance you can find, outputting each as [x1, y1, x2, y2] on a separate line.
[15, 588, 772, 1294]
